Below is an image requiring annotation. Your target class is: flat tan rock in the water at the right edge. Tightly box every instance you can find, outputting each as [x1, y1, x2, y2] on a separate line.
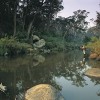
[85, 68, 100, 78]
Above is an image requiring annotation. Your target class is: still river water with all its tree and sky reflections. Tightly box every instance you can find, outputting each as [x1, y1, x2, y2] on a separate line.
[0, 50, 100, 100]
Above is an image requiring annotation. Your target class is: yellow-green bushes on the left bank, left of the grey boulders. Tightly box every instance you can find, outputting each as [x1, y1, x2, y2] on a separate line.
[0, 37, 32, 56]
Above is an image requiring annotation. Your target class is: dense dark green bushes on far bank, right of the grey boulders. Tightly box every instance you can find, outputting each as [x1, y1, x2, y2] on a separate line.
[43, 36, 80, 52]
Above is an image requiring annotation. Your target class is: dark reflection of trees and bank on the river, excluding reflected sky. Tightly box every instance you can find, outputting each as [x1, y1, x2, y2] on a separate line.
[0, 50, 100, 100]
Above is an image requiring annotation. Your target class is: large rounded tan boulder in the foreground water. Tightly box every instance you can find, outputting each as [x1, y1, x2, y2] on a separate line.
[25, 84, 64, 100]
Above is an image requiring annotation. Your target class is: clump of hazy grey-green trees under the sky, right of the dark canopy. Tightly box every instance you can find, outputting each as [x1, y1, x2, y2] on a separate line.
[52, 10, 89, 41]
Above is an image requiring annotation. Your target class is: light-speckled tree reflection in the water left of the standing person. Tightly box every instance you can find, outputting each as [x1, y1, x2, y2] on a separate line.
[51, 51, 86, 87]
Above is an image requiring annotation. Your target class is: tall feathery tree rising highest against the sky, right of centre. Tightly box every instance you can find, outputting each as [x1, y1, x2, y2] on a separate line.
[65, 10, 89, 42]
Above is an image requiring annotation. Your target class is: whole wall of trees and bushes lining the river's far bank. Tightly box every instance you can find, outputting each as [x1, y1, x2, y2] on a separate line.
[0, 0, 100, 56]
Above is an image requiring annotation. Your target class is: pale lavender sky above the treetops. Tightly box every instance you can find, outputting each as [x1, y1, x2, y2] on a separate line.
[57, 0, 100, 27]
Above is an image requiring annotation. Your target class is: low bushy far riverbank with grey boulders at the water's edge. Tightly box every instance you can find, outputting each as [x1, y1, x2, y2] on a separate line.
[0, 35, 80, 56]
